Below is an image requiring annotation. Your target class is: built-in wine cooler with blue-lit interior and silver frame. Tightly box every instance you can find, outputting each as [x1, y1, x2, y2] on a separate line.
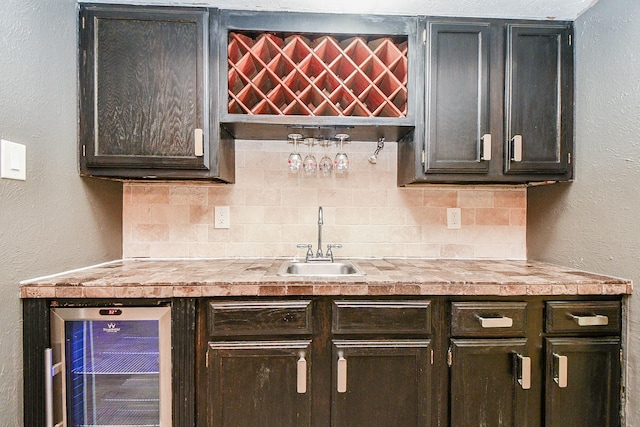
[45, 307, 171, 427]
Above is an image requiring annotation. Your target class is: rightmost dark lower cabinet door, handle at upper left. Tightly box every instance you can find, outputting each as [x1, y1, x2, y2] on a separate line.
[545, 337, 620, 427]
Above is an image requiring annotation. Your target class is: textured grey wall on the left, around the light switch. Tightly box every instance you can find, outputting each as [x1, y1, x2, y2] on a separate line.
[0, 0, 122, 427]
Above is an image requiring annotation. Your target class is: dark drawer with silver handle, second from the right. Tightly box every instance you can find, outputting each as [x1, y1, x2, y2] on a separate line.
[451, 301, 527, 337]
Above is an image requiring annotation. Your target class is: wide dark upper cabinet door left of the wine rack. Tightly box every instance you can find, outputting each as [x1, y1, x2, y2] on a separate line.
[80, 6, 209, 175]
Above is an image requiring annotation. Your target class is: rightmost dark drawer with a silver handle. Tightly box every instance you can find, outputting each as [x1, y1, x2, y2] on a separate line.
[545, 301, 621, 334]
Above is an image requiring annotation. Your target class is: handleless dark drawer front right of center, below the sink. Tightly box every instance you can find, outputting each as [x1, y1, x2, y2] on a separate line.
[332, 300, 431, 335]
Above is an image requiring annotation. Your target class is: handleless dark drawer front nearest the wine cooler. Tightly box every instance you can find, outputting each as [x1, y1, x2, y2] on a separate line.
[207, 301, 312, 336]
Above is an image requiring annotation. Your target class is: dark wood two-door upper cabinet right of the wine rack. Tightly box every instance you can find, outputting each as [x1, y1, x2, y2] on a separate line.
[398, 18, 573, 185]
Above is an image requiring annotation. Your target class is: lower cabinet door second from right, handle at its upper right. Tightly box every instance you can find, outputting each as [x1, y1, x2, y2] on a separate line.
[450, 339, 538, 427]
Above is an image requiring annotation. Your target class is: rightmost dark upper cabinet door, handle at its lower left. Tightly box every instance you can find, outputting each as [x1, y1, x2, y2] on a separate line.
[504, 24, 573, 179]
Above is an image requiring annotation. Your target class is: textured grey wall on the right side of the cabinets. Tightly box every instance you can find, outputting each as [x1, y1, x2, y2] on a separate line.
[527, 0, 640, 426]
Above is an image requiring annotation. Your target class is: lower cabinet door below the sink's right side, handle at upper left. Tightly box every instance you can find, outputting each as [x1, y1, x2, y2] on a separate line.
[331, 340, 432, 427]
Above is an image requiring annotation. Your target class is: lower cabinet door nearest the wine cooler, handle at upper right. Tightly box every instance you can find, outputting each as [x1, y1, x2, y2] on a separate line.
[207, 340, 311, 427]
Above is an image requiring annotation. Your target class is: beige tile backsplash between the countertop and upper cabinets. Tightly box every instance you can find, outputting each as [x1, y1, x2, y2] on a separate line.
[123, 141, 526, 259]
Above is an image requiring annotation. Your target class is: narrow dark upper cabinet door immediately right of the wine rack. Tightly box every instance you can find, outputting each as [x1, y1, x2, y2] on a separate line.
[425, 21, 491, 174]
